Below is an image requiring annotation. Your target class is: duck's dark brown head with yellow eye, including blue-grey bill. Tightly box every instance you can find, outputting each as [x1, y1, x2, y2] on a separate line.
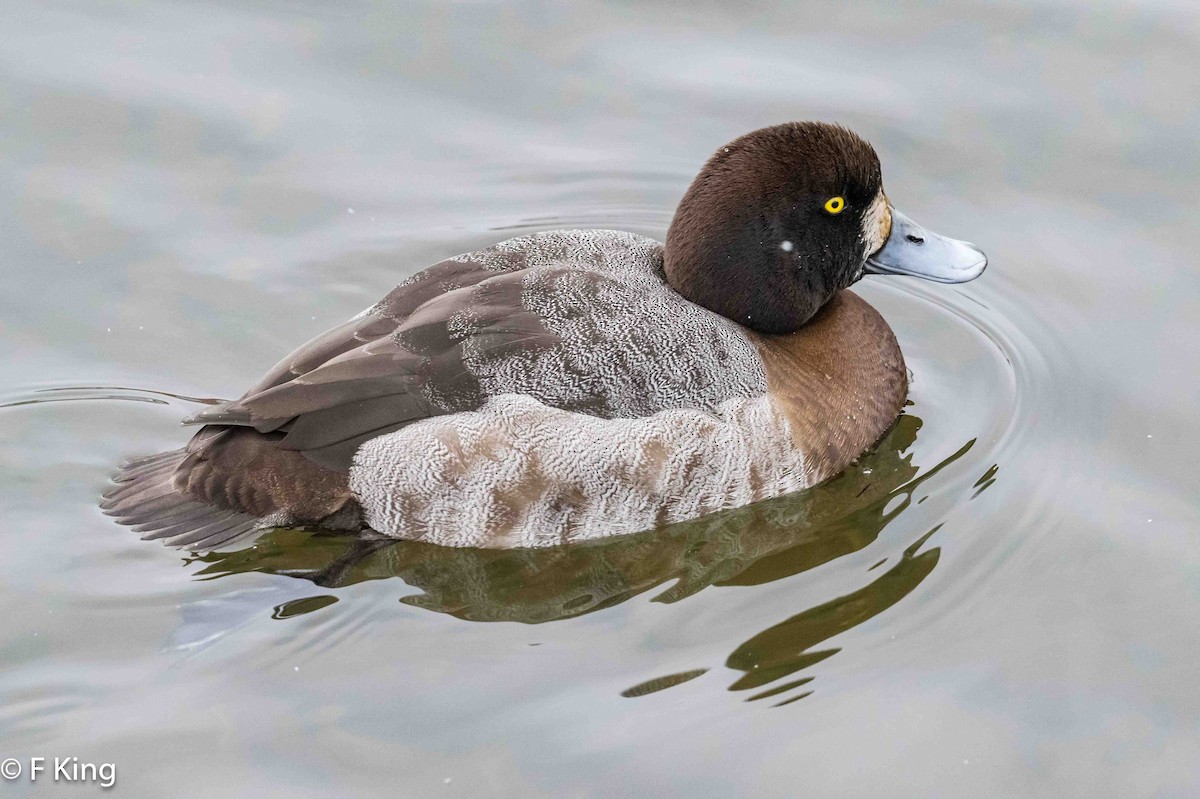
[665, 122, 986, 334]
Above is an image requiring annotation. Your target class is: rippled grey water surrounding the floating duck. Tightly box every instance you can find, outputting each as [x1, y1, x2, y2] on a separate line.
[0, 0, 1200, 798]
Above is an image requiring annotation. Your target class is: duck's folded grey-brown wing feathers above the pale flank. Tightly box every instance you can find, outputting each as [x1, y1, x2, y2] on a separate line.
[185, 255, 558, 471]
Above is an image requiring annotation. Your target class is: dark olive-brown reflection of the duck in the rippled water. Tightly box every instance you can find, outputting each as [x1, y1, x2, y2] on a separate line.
[196, 415, 974, 704]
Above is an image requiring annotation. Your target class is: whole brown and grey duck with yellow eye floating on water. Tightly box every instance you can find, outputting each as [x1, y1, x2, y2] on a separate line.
[101, 121, 988, 549]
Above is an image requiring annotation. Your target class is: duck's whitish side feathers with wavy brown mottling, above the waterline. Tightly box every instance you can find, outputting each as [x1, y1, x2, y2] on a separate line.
[350, 395, 810, 547]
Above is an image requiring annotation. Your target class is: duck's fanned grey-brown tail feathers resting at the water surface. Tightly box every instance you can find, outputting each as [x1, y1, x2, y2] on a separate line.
[100, 449, 259, 551]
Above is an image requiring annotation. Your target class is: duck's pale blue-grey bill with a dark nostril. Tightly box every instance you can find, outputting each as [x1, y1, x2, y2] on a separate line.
[866, 209, 988, 283]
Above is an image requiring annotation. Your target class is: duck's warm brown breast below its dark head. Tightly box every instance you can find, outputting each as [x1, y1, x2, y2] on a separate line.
[748, 290, 908, 481]
